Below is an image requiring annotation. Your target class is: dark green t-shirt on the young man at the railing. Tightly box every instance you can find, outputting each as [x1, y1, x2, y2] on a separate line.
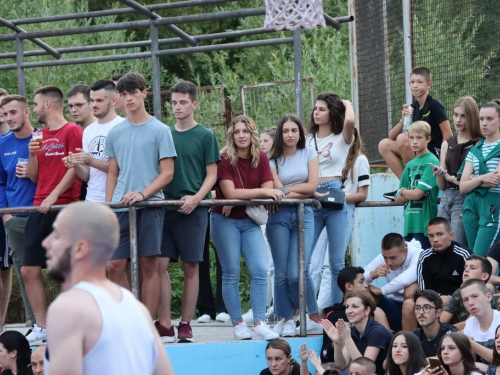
[164, 124, 220, 210]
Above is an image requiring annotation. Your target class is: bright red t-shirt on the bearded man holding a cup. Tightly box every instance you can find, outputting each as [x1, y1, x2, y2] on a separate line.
[33, 122, 83, 206]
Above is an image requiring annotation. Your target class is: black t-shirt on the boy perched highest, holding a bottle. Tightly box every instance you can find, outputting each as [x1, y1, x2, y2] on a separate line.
[411, 95, 448, 159]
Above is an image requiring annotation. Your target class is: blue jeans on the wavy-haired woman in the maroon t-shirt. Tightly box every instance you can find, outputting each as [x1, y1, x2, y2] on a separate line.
[210, 212, 267, 325]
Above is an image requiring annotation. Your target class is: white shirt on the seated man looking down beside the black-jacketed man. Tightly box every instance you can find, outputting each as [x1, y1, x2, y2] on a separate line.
[364, 239, 422, 302]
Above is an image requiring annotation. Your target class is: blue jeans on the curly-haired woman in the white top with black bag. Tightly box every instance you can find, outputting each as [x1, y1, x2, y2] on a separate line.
[313, 180, 347, 304]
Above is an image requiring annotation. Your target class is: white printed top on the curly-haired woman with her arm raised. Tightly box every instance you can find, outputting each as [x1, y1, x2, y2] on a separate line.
[306, 133, 351, 177]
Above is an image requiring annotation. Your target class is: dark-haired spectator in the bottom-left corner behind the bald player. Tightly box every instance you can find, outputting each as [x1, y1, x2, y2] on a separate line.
[0, 331, 31, 375]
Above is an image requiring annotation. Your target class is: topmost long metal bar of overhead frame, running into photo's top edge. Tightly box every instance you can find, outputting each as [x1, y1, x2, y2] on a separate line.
[10, 0, 241, 25]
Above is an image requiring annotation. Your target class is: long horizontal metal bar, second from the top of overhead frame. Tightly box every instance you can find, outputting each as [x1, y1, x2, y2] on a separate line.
[0, 8, 266, 42]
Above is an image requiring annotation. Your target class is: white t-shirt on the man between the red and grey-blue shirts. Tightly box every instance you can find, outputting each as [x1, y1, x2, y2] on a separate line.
[82, 116, 123, 202]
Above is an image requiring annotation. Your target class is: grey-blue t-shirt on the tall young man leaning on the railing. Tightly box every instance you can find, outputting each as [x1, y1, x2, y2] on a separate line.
[104, 117, 177, 202]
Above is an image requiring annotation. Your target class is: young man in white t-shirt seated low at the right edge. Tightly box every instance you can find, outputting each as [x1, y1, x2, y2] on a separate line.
[460, 279, 500, 362]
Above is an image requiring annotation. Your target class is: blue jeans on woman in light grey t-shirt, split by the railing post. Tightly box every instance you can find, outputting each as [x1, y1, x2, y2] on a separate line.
[266, 206, 318, 318]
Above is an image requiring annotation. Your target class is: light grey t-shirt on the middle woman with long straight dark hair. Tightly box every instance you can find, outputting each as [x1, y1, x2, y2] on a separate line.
[269, 147, 318, 186]
